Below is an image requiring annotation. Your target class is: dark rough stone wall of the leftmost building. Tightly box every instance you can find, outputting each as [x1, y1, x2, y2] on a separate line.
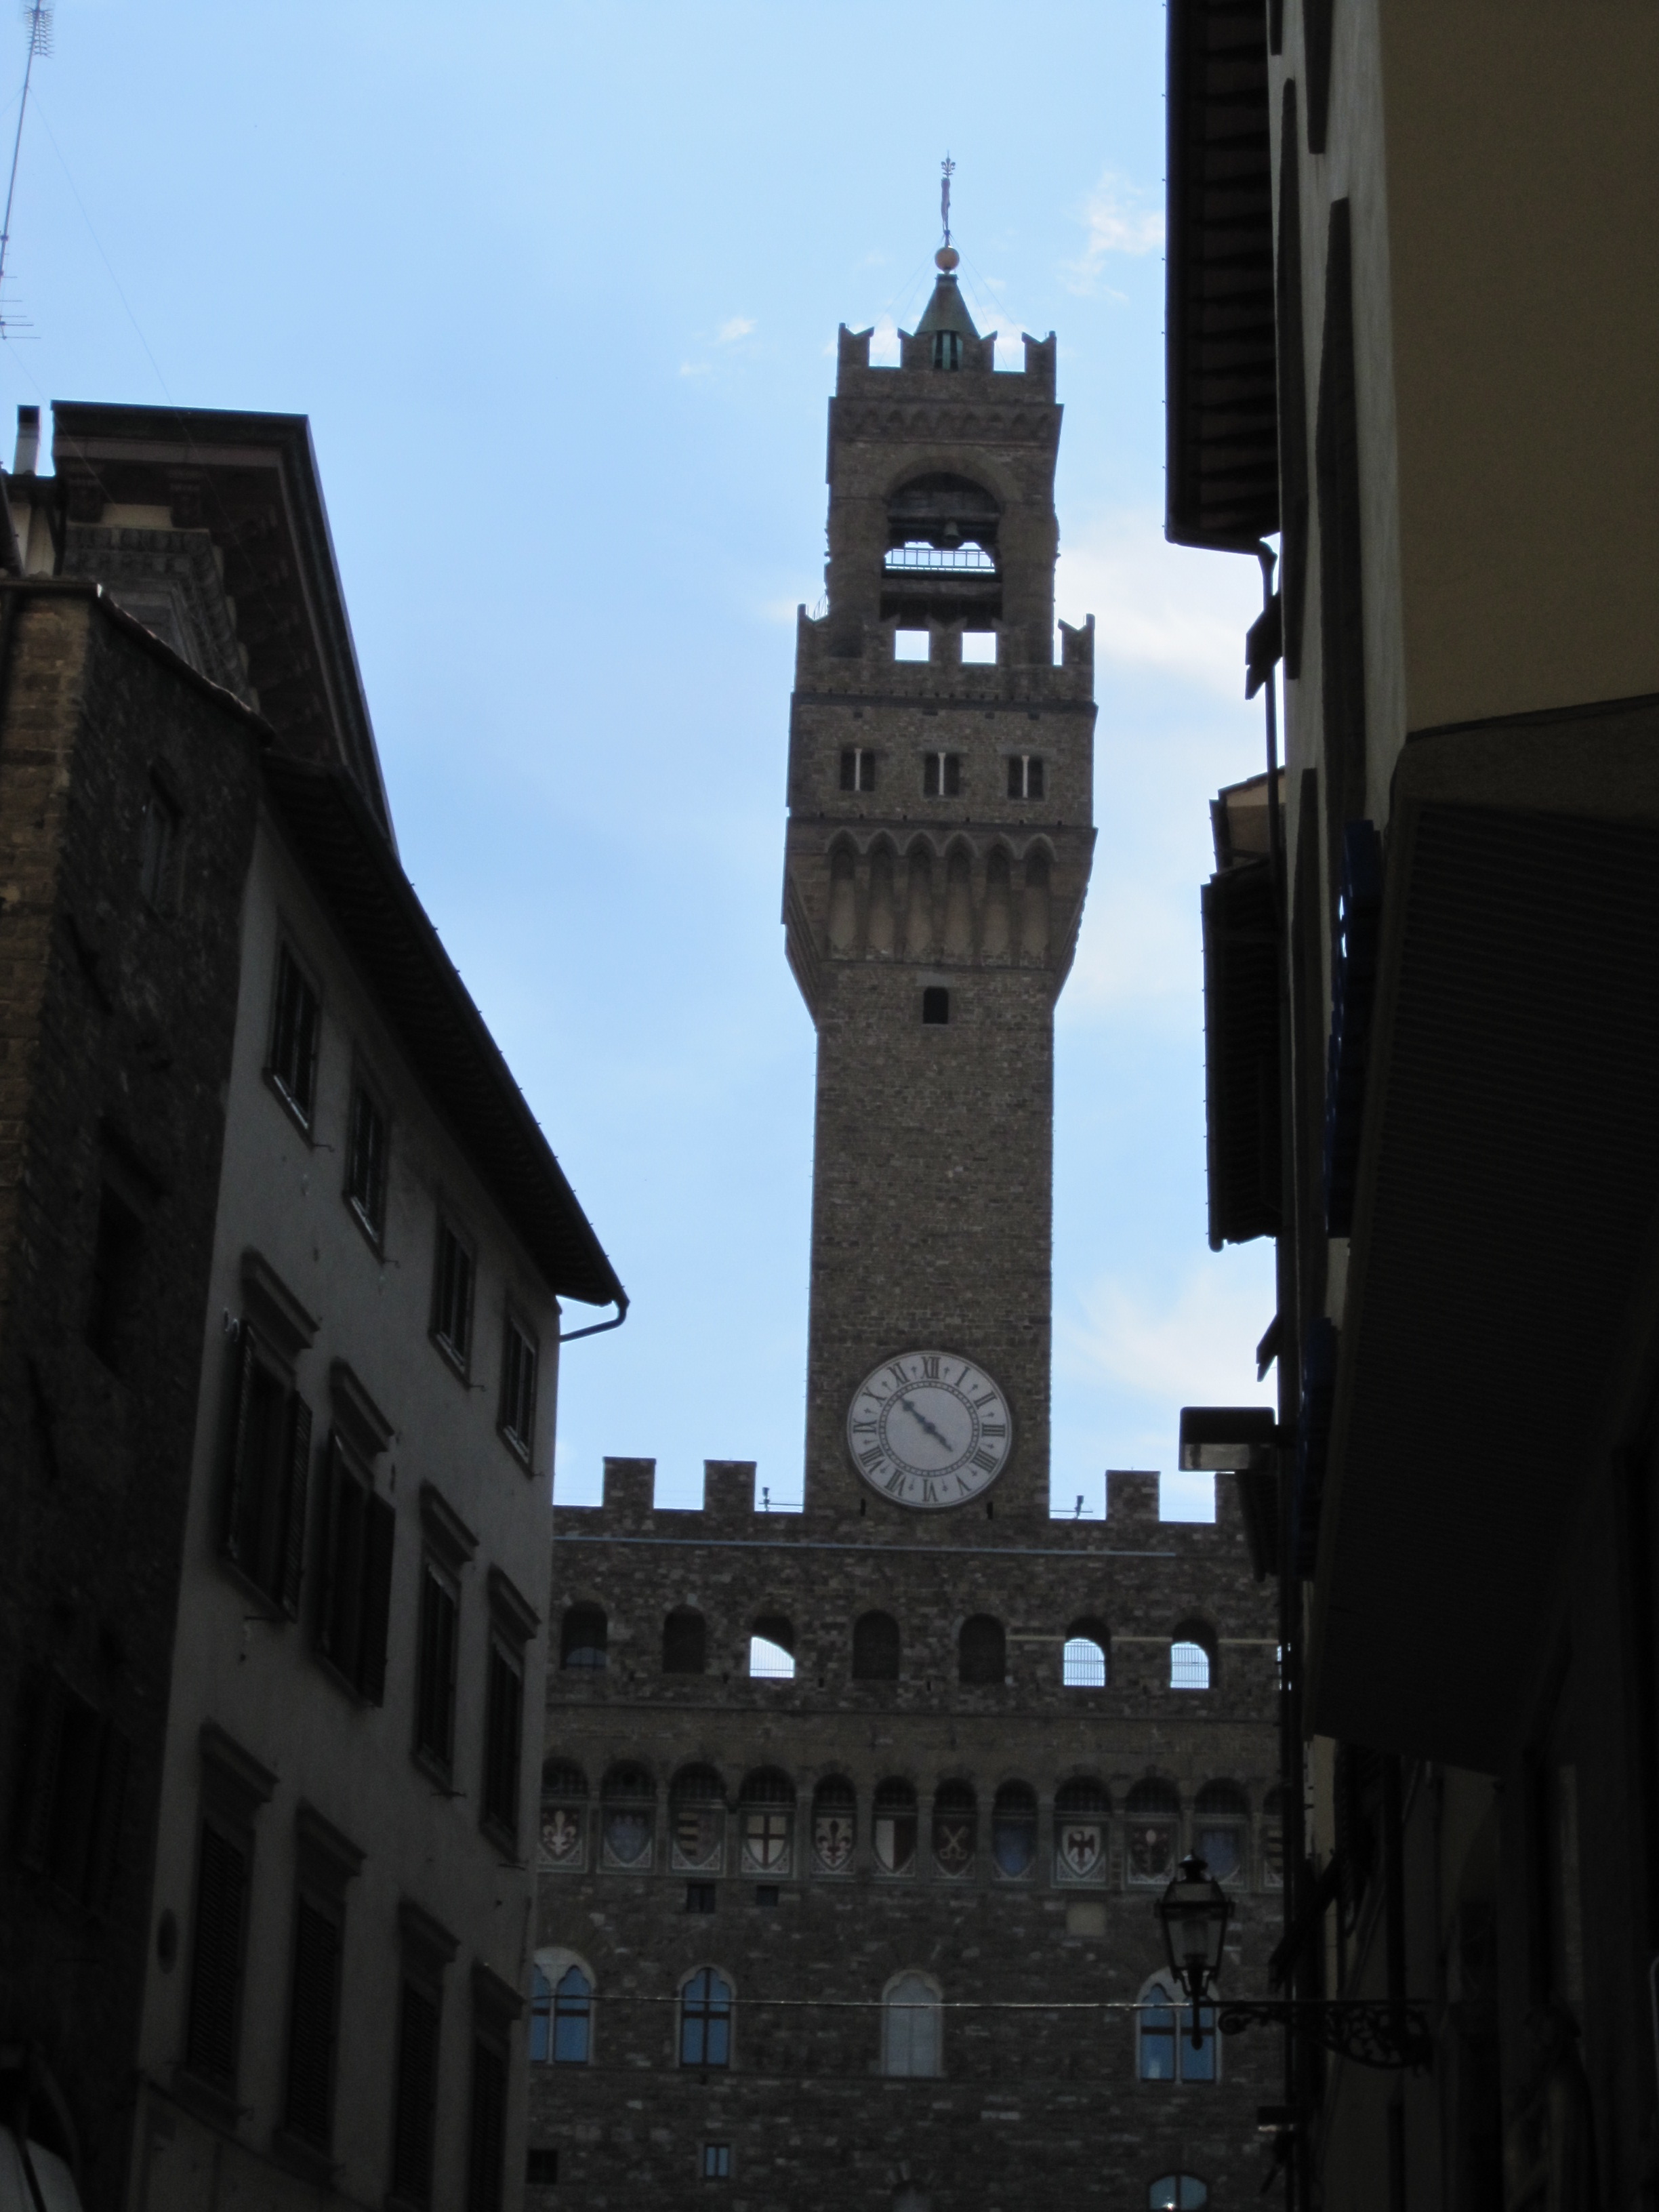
[0, 584, 259, 2212]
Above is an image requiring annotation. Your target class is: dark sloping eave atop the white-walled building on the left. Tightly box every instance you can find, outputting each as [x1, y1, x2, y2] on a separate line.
[266, 752, 628, 1312]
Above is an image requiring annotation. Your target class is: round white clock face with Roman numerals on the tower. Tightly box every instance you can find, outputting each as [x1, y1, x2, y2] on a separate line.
[847, 1351, 1013, 1511]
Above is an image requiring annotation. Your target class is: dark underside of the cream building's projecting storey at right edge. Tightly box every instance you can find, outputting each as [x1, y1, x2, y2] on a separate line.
[1307, 699, 1659, 1771]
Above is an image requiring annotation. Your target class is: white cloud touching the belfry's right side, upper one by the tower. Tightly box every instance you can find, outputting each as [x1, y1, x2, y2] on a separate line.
[1055, 509, 1261, 699]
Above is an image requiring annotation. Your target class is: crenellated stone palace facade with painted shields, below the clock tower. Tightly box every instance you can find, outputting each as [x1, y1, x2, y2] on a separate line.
[529, 1460, 1281, 2212]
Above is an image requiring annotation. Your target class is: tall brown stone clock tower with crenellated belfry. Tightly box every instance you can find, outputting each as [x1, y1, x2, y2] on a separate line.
[783, 245, 1095, 1542]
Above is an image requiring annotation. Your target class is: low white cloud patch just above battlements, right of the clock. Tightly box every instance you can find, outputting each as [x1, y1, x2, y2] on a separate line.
[1059, 1258, 1272, 1405]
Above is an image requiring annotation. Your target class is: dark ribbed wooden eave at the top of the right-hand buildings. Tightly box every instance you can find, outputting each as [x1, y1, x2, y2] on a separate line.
[1164, 0, 1279, 553]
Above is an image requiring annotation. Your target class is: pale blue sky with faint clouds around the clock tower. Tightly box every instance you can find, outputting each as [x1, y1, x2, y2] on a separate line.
[0, 0, 1274, 1511]
